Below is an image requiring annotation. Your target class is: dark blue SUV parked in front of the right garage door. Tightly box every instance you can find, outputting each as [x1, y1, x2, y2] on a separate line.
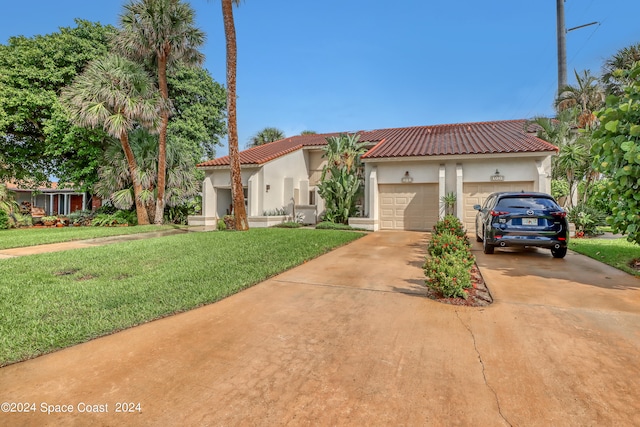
[473, 192, 569, 258]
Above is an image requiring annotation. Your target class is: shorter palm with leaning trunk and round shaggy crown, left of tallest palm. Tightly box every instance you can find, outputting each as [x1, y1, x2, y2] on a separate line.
[61, 54, 162, 224]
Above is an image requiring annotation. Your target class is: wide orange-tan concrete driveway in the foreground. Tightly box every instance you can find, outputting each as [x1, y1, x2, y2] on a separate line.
[0, 232, 640, 426]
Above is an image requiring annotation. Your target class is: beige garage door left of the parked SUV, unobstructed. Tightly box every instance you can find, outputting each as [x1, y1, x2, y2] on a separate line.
[378, 184, 438, 231]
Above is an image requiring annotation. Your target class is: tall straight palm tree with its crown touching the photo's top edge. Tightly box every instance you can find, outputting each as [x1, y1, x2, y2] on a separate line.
[114, 0, 205, 224]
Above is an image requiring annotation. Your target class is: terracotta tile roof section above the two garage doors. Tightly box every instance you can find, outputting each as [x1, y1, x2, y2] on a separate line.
[360, 120, 558, 159]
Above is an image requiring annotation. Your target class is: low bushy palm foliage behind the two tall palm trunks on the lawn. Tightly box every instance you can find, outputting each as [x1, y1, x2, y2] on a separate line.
[94, 129, 198, 219]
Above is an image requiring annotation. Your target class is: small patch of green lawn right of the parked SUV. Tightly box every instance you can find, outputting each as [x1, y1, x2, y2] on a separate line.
[569, 238, 640, 277]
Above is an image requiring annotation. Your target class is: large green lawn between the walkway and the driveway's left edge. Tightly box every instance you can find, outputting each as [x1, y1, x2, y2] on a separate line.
[0, 228, 362, 366]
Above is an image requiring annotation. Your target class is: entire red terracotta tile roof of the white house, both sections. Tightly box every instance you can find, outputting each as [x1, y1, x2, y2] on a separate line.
[198, 120, 558, 167]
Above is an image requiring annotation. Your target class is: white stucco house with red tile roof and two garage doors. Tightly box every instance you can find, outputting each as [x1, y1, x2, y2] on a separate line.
[190, 120, 558, 230]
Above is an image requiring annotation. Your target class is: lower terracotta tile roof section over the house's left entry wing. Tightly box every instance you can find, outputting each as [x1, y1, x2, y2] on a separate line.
[198, 133, 339, 167]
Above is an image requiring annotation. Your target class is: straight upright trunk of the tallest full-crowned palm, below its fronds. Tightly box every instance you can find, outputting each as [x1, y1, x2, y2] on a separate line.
[153, 56, 169, 224]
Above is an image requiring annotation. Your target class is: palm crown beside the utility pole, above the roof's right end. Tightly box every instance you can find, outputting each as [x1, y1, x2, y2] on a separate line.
[555, 70, 605, 129]
